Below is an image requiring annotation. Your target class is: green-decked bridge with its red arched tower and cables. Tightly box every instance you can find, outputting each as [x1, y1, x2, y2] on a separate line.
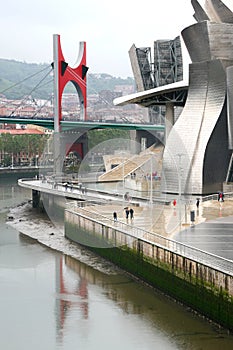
[0, 35, 169, 133]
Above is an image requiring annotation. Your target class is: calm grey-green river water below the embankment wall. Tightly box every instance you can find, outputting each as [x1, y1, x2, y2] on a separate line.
[0, 180, 233, 350]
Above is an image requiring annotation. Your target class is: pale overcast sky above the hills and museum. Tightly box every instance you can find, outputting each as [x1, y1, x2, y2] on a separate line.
[0, 0, 233, 78]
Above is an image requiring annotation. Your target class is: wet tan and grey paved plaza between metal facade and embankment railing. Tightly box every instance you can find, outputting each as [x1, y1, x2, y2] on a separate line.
[85, 199, 233, 260]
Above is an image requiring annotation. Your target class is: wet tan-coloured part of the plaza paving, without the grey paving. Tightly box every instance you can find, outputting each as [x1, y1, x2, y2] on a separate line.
[83, 199, 233, 238]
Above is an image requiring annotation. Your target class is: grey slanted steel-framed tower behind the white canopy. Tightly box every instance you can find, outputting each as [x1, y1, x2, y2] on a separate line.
[129, 36, 183, 124]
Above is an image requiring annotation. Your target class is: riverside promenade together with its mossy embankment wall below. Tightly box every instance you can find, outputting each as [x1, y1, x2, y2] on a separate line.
[18, 179, 233, 331]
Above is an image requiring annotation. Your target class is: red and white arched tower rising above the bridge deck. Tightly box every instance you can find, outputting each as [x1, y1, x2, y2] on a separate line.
[52, 34, 88, 131]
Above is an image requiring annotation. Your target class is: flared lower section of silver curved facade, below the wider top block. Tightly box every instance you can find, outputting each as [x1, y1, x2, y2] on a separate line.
[163, 60, 230, 194]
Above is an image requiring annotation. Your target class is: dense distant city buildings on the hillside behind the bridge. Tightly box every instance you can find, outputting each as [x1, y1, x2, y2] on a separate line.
[0, 80, 146, 129]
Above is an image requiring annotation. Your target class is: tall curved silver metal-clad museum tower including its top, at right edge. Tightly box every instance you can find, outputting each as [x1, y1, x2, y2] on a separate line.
[163, 0, 233, 194]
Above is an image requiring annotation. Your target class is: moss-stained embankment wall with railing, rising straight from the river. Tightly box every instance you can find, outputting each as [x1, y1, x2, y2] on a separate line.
[65, 209, 233, 331]
